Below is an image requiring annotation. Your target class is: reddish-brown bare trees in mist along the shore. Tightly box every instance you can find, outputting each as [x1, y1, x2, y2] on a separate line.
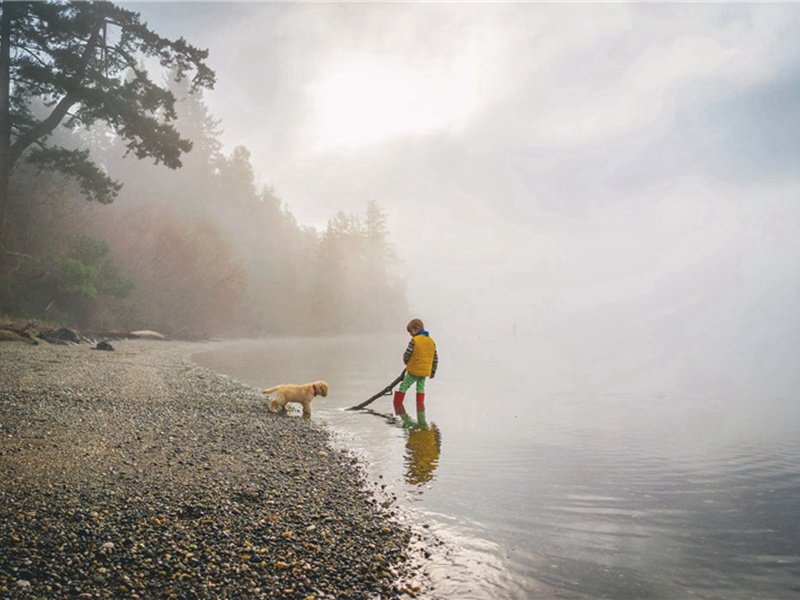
[81, 204, 247, 337]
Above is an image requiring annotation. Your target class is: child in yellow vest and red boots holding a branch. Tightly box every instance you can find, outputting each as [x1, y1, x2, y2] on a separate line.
[394, 319, 439, 427]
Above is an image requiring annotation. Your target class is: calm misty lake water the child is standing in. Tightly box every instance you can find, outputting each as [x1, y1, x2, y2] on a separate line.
[192, 332, 800, 599]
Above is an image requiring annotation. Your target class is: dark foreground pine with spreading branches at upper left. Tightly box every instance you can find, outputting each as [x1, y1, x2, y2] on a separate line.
[0, 0, 215, 243]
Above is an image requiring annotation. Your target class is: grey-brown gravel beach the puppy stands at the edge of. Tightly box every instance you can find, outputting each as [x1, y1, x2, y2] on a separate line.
[0, 340, 413, 599]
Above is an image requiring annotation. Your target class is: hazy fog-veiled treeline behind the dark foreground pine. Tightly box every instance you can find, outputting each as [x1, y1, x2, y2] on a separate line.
[0, 82, 407, 337]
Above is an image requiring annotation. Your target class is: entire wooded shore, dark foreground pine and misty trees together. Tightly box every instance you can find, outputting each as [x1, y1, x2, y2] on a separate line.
[0, 2, 407, 338]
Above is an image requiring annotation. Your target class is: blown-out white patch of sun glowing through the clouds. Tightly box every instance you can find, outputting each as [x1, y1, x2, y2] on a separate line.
[311, 58, 475, 151]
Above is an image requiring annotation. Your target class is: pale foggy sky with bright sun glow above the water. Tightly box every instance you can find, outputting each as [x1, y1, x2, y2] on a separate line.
[128, 2, 800, 392]
